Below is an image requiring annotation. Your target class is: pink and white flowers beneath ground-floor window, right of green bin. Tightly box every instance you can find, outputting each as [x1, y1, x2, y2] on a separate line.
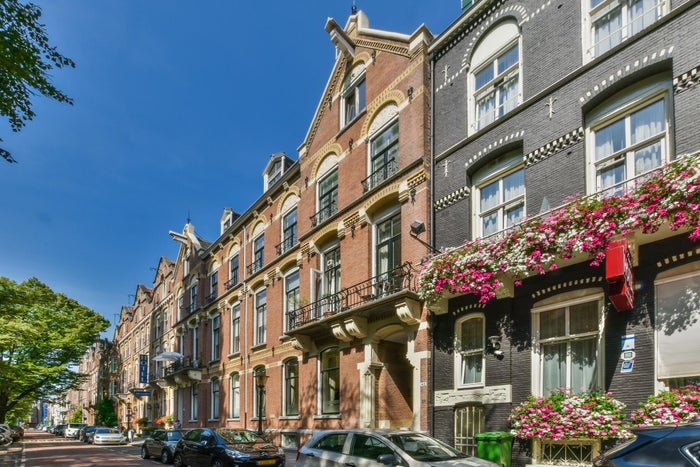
[508, 389, 631, 440]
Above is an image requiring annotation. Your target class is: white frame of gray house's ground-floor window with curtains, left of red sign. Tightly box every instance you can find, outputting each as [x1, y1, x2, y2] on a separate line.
[531, 289, 605, 396]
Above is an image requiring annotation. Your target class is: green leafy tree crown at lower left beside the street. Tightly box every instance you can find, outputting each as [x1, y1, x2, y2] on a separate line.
[0, 278, 109, 422]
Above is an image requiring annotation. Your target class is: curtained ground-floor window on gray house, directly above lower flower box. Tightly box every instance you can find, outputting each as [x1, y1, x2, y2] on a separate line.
[532, 294, 604, 395]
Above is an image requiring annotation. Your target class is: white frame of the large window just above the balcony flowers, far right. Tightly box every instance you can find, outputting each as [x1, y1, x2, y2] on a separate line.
[586, 75, 673, 194]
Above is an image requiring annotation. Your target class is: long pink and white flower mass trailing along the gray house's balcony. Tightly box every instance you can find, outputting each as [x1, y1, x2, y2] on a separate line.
[419, 153, 700, 303]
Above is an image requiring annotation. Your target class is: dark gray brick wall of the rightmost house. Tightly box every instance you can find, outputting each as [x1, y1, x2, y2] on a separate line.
[431, 0, 700, 465]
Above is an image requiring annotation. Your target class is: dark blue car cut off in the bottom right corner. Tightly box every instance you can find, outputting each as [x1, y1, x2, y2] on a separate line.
[593, 418, 700, 467]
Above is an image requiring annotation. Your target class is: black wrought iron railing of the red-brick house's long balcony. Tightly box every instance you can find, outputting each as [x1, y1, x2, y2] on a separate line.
[287, 262, 415, 331]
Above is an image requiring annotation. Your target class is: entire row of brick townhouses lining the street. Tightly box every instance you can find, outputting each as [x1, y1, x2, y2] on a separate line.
[68, 0, 700, 465]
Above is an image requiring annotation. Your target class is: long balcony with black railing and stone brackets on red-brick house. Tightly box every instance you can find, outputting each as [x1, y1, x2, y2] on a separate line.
[287, 262, 417, 335]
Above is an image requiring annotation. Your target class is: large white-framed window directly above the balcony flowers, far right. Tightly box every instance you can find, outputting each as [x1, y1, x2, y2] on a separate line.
[586, 75, 671, 194]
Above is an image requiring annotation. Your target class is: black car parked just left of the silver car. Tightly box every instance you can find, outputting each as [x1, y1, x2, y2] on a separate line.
[173, 428, 284, 467]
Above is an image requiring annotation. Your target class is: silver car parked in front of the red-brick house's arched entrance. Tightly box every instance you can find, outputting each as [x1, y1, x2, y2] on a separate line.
[295, 429, 498, 467]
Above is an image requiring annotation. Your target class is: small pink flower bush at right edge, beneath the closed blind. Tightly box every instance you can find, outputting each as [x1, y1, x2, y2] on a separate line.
[630, 385, 700, 426]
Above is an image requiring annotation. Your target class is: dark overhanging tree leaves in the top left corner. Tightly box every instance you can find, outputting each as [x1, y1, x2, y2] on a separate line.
[0, 0, 75, 162]
